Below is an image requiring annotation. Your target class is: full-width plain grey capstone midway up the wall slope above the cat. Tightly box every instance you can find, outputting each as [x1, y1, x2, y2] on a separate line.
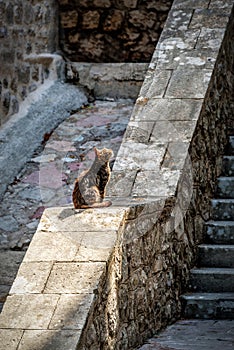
[132, 98, 202, 121]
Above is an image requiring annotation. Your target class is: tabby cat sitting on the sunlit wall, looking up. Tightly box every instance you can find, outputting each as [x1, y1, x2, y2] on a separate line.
[72, 147, 113, 209]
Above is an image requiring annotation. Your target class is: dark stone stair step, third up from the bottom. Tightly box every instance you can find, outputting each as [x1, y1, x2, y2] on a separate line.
[197, 244, 234, 267]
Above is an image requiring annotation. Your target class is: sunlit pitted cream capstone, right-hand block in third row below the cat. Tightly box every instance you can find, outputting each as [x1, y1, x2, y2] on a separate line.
[45, 262, 106, 294]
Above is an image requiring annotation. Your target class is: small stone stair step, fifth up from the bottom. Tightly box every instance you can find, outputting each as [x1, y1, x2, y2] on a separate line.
[211, 199, 234, 221]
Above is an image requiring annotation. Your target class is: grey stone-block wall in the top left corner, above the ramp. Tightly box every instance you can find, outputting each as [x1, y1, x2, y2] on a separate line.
[0, 0, 58, 124]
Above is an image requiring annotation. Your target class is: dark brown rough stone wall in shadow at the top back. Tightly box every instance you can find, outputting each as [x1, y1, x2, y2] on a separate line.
[59, 0, 172, 62]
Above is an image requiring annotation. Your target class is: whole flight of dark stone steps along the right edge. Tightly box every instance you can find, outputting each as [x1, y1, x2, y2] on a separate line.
[182, 136, 234, 319]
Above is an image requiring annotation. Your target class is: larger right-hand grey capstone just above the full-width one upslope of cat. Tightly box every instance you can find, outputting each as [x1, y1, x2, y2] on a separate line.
[165, 68, 212, 98]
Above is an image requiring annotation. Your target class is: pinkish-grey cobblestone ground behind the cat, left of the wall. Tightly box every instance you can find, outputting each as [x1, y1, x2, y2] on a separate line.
[0, 100, 133, 308]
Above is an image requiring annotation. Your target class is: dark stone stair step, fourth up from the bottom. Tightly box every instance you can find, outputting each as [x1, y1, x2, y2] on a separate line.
[205, 221, 234, 244]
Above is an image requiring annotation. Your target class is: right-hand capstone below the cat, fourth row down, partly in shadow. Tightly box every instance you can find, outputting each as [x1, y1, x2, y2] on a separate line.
[49, 294, 94, 331]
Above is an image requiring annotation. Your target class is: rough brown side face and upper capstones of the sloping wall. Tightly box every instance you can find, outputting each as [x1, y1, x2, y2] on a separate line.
[78, 1, 234, 350]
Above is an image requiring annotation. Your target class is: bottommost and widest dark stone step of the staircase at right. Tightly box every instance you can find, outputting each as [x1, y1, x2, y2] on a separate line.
[181, 293, 234, 320]
